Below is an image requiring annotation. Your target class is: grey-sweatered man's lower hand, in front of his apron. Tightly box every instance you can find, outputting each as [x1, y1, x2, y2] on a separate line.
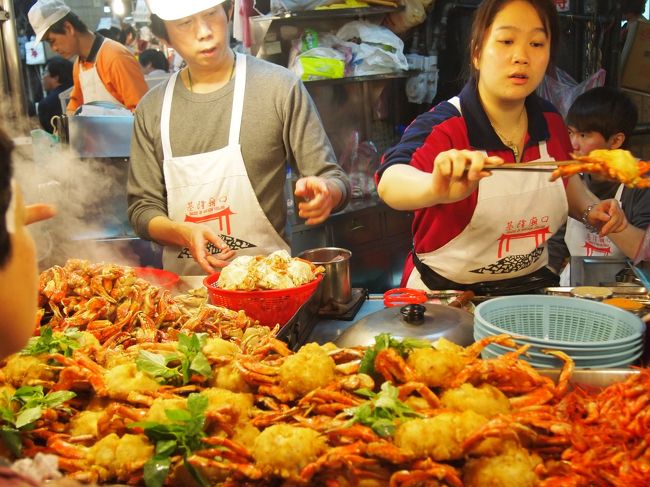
[178, 222, 235, 274]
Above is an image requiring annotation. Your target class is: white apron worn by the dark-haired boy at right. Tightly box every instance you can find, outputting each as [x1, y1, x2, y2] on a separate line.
[560, 184, 625, 286]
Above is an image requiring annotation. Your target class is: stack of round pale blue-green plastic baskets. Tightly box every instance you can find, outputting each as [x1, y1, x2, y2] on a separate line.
[474, 295, 645, 369]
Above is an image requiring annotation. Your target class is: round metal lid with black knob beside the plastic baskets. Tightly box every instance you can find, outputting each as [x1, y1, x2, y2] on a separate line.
[334, 303, 474, 347]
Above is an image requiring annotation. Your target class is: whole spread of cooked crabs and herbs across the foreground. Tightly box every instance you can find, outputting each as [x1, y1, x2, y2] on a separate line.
[0, 262, 650, 487]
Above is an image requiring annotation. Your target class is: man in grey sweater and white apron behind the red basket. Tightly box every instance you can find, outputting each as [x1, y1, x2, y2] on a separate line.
[127, 0, 350, 275]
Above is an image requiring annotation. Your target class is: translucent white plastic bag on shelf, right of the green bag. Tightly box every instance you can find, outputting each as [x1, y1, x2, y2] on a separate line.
[336, 21, 408, 76]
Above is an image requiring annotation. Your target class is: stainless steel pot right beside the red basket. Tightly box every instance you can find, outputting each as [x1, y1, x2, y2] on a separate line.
[298, 247, 352, 306]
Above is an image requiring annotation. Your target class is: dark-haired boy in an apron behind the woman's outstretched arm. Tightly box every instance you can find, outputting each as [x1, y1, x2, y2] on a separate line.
[549, 87, 650, 286]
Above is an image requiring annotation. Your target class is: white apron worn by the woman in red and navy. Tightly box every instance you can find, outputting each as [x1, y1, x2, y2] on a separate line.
[407, 97, 568, 289]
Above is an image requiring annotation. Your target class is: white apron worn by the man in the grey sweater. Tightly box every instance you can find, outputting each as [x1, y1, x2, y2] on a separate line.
[160, 54, 289, 275]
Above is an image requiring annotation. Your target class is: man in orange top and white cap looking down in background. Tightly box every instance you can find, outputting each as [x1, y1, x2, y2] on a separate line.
[28, 0, 148, 113]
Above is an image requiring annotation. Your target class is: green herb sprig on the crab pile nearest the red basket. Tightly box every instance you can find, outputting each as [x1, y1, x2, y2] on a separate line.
[135, 333, 212, 385]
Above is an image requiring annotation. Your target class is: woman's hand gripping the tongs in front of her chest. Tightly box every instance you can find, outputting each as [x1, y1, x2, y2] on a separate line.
[431, 149, 503, 203]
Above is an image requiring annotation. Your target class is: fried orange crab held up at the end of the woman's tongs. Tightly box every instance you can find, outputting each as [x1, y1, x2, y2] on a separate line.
[551, 149, 650, 188]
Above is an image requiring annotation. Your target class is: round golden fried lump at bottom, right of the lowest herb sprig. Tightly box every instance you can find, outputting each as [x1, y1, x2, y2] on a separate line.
[251, 424, 327, 478]
